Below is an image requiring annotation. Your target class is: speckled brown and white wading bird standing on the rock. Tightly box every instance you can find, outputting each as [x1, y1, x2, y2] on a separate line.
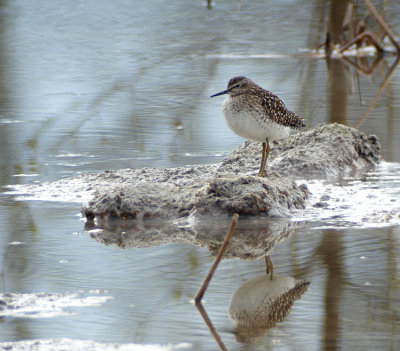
[210, 76, 306, 177]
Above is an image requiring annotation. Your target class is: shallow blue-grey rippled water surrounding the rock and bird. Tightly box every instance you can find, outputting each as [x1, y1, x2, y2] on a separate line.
[0, 0, 400, 350]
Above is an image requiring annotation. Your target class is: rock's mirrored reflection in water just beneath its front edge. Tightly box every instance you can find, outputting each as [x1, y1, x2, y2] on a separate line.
[85, 213, 305, 259]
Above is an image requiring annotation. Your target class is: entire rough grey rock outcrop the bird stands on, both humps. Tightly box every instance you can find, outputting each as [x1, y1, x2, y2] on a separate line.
[82, 124, 380, 220]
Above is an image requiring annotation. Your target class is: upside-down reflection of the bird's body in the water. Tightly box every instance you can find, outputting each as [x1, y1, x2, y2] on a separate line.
[229, 274, 310, 343]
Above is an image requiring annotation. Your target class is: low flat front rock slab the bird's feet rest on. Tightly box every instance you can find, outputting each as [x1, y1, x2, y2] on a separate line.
[82, 172, 308, 219]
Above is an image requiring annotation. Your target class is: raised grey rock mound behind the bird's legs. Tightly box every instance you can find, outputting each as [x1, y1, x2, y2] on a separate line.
[218, 123, 381, 180]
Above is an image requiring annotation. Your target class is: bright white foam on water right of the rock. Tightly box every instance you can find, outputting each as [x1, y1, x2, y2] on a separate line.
[295, 162, 400, 229]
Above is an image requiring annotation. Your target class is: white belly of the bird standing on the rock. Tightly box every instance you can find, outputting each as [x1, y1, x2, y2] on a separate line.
[222, 96, 290, 142]
